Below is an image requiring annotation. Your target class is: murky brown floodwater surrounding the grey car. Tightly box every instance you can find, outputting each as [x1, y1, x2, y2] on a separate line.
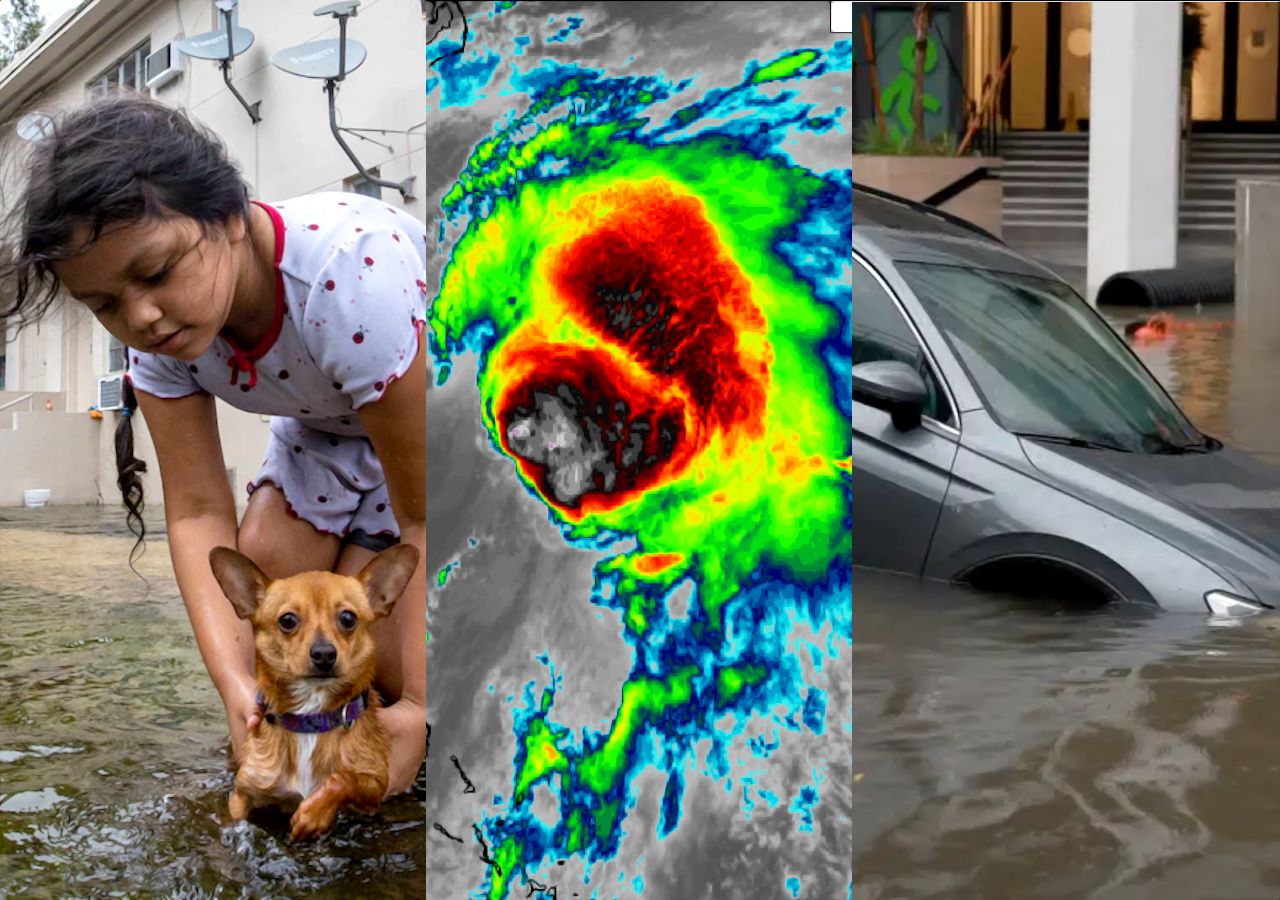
[854, 299, 1280, 900]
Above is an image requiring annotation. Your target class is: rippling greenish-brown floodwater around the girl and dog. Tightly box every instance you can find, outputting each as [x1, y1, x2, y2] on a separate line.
[0, 507, 426, 899]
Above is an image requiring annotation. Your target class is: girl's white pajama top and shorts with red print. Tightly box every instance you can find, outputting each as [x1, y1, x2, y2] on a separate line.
[129, 193, 426, 549]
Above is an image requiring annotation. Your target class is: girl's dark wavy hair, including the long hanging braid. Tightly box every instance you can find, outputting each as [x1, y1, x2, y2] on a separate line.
[0, 93, 248, 565]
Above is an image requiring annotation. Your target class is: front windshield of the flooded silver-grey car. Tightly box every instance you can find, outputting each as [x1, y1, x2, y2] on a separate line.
[900, 262, 1204, 452]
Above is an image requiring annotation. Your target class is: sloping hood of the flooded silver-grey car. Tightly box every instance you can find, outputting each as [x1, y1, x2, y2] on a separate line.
[1021, 439, 1280, 607]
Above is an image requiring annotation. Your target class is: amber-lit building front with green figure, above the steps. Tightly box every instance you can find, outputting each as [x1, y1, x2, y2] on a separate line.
[854, 1, 1280, 136]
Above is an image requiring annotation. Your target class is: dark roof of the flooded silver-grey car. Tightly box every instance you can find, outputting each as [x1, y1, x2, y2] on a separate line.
[854, 184, 1056, 280]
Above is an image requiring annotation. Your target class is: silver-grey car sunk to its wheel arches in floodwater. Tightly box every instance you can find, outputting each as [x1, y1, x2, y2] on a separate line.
[852, 187, 1280, 615]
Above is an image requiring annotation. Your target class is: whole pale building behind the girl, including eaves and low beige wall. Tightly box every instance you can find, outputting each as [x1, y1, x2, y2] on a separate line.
[0, 0, 426, 506]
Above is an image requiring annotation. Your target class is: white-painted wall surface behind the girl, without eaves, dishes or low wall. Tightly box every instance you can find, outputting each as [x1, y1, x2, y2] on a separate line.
[0, 0, 426, 506]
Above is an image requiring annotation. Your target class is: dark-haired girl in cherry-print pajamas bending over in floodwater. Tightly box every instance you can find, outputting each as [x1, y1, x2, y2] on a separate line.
[0, 96, 428, 794]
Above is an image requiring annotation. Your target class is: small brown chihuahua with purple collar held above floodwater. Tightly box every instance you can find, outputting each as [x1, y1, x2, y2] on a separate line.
[209, 544, 419, 841]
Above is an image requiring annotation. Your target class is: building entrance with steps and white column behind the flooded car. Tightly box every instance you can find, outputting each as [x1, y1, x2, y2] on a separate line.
[854, 0, 1280, 297]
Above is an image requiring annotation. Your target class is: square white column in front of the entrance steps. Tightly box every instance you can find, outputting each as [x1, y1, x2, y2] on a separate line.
[1087, 0, 1181, 302]
